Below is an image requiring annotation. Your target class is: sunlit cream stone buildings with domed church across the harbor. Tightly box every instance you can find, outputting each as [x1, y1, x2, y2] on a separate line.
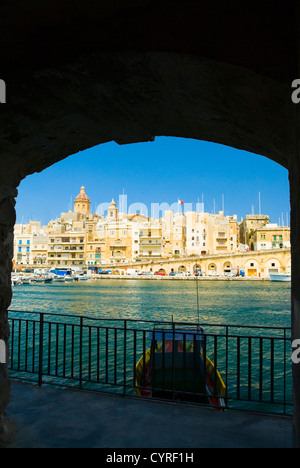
[14, 187, 290, 267]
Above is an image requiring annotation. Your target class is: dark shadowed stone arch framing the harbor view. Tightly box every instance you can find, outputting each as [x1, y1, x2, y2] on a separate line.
[0, 0, 300, 446]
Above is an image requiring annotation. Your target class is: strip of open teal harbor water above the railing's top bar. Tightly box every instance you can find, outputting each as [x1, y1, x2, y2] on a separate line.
[11, 279, 291, 327]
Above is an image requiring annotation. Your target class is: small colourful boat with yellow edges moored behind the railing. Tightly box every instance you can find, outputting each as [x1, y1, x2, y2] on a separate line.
[135, 328, 226, 409]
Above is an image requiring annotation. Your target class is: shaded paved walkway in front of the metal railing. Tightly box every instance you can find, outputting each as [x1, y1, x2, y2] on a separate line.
[3, 383, 292, 449]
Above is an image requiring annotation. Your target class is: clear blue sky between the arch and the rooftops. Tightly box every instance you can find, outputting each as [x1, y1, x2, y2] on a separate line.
[16, 137, 290, 225]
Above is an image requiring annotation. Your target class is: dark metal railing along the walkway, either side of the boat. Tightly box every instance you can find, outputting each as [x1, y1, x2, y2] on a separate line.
[9, 310, 293, 415]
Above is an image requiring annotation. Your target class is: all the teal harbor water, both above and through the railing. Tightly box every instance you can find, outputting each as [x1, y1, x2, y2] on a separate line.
[10, 279, 292, 414]
